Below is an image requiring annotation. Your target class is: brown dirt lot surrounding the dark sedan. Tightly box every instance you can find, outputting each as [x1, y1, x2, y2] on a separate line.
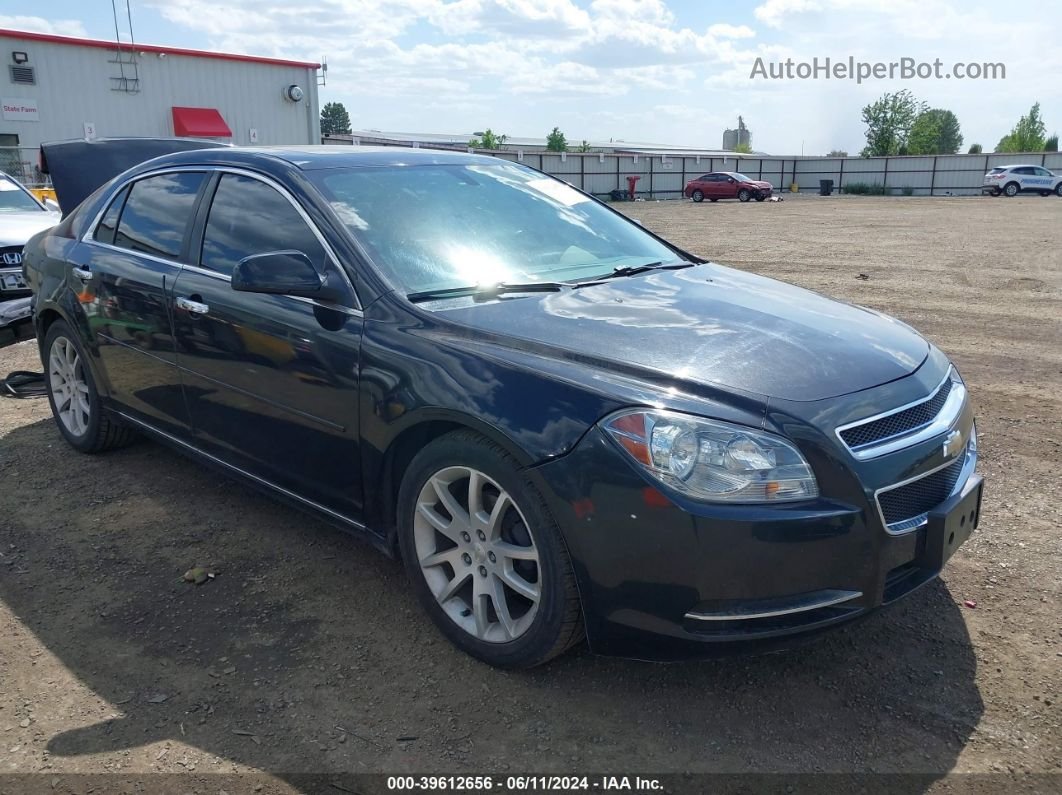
[0, 196, 1062, 793]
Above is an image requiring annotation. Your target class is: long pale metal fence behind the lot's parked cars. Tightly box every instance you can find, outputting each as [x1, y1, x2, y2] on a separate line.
[481, 152, 1062, 198]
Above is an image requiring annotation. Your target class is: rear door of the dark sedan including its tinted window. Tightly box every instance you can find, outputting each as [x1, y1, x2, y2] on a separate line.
[72, 170, 206, 436]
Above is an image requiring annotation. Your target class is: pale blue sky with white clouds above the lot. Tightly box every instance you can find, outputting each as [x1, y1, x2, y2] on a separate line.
[0, 0, 1062, 155]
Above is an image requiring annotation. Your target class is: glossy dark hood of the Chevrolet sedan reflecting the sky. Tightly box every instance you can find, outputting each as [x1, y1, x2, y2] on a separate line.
[435, 264, 929, 400]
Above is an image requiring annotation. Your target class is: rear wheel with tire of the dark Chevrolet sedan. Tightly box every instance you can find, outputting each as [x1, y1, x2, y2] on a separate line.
[44, 321, 136, 453]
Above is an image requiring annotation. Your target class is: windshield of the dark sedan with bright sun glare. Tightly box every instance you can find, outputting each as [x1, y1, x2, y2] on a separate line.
[310, 162, 681, 293]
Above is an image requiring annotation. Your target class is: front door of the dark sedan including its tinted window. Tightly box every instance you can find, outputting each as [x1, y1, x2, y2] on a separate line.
[168, 171, 361, 520]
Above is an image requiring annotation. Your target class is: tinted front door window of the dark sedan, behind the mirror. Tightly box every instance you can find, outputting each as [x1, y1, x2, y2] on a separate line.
[200, 174, 325, 275]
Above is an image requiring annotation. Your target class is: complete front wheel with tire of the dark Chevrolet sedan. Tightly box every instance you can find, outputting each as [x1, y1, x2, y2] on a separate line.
[398, 431, 584, 668]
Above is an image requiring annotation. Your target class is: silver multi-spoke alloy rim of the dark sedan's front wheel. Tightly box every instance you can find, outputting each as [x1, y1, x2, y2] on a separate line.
[413, 466, 543, 643]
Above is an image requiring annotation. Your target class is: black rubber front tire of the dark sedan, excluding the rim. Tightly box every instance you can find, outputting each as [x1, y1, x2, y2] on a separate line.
[396, 431, 585, 668]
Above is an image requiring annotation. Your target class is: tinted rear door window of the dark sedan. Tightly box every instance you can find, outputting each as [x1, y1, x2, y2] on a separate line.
[115, 171, 204, 260]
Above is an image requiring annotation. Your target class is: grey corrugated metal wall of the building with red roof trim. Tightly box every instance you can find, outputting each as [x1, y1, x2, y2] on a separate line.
[0, 37, 321, 156]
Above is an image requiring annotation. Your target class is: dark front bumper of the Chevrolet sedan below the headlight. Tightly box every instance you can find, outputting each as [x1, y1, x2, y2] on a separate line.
[534, 360, 982, 660]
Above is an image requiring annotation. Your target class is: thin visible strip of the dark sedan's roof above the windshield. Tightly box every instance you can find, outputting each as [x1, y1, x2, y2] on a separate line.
[140, 144, 497, 171]
